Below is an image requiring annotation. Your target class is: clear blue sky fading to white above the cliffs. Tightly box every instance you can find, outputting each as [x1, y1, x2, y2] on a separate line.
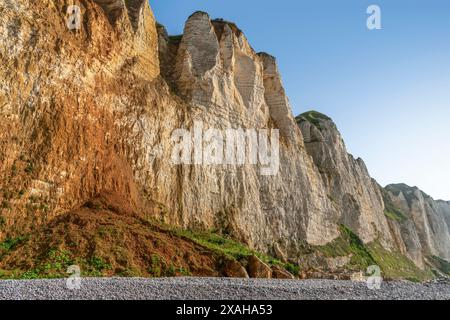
[150, 0, 450, 200]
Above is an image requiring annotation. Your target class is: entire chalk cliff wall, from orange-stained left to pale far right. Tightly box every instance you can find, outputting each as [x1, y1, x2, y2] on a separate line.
[0, 0, 450, 276]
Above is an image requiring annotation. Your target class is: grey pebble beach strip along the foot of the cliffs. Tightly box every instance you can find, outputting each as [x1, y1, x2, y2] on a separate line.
[0, 278, 450, 300]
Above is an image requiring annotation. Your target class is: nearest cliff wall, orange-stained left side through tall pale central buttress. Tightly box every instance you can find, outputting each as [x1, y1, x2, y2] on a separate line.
[0, 1, 338, 256]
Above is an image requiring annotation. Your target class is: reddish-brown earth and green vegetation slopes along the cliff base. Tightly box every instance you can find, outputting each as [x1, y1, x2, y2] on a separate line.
[0, 195, 440, 281]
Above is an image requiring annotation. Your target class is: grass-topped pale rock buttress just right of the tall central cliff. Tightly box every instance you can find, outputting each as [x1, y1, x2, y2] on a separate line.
[297, 112, 393, 248]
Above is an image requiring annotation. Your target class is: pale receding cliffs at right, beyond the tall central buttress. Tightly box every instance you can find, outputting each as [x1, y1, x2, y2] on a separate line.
[297, 111, 450, 269]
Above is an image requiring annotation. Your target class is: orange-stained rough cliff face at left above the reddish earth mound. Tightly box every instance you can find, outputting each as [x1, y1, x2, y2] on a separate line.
[0, 0, 165, 238]
